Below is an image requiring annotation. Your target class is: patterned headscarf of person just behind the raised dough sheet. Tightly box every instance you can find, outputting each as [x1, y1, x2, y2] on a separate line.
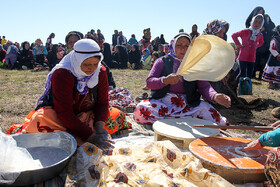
[203, 19, 229, 35]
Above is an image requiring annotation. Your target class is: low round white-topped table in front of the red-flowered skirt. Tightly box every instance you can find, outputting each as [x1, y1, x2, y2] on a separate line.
[153, 118, 220, 149]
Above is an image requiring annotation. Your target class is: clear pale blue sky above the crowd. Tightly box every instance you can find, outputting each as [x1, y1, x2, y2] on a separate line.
[0, 0, 280, 43]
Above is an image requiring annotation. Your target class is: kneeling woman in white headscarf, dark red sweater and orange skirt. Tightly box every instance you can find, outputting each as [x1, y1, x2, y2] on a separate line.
[23, 39, 114, 149]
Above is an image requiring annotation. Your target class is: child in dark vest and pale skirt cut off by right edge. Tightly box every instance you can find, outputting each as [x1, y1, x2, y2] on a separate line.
[262, 25, 280, 89]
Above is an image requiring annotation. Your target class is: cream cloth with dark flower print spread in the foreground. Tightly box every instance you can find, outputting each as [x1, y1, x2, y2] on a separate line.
[65, 141, 232, 187]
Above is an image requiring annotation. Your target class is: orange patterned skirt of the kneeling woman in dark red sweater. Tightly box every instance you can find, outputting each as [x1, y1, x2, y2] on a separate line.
[7, 106, 131, 142]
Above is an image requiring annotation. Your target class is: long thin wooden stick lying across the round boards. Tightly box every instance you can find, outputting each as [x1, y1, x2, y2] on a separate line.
[193, 125, 273, 131]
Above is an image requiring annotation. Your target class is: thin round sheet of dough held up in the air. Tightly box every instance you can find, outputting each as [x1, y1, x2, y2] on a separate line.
[177, 35, 235, 81]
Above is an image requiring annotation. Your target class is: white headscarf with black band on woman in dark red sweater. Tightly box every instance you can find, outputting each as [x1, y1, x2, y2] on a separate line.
[38, 39, 103, 104]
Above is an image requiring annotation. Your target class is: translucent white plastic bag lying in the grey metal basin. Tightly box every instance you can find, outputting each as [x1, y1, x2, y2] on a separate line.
[0, 128, 42, 184]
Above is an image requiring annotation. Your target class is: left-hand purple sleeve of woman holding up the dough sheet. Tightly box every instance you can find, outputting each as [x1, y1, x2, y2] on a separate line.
[146, 58, 166, 90]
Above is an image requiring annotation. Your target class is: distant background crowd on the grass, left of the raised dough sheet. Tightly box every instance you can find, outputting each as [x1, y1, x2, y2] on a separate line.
[0, 28, 168, 71]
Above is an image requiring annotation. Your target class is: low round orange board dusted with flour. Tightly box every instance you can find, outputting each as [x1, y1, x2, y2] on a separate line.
[189, 137, 271, 184]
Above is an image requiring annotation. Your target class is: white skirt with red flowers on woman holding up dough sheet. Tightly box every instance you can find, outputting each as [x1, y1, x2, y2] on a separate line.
[134, 93, 229, 125]
